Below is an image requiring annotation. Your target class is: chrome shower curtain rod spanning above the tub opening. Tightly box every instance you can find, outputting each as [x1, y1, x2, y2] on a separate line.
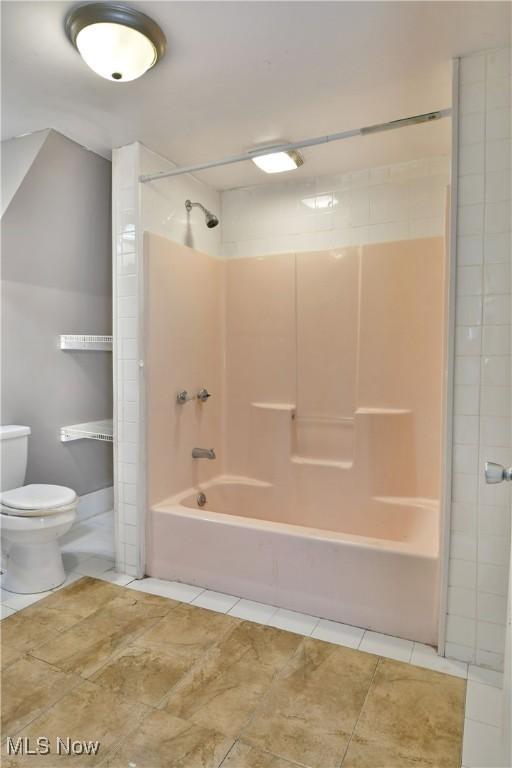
[139, 109, 452, 184]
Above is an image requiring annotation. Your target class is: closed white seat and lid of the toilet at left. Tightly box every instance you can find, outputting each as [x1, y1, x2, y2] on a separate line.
[0, 483, 77, 517]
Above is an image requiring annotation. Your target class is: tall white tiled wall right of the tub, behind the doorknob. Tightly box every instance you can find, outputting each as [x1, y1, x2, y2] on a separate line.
[446, 48, 512, 669]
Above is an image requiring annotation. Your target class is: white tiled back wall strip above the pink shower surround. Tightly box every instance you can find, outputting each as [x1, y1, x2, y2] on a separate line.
[222, 156, 448, 258]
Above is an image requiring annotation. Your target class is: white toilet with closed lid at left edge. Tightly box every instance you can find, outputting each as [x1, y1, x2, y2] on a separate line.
[0, 425, 78, 594]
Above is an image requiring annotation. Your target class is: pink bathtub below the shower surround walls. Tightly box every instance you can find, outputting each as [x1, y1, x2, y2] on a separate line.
[146, 476, 439, 645]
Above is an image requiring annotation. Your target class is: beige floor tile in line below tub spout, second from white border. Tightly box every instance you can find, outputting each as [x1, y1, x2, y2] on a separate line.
[163, 646, 273, 738]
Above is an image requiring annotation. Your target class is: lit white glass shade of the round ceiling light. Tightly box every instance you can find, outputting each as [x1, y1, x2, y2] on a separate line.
[76, 24, 156, 83]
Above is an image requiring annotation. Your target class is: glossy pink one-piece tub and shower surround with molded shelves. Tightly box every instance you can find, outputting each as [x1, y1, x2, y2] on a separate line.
[144, 233, 445, 643]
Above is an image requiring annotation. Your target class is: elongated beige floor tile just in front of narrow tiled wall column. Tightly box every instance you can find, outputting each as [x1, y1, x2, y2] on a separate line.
[32, 593, 172, 677]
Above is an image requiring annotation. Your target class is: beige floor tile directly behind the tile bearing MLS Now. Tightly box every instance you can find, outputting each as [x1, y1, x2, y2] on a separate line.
[91, 645, 193, 706]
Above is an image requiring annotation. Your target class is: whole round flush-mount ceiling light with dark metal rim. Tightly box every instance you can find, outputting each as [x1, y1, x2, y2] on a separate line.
[64, 3, 166, 83]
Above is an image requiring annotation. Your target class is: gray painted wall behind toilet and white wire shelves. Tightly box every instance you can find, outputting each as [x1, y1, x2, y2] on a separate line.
[1, 131, 112, 495]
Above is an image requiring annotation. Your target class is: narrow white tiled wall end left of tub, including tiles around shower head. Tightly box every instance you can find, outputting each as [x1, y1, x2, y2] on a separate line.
[112, 143, 220, 577]
